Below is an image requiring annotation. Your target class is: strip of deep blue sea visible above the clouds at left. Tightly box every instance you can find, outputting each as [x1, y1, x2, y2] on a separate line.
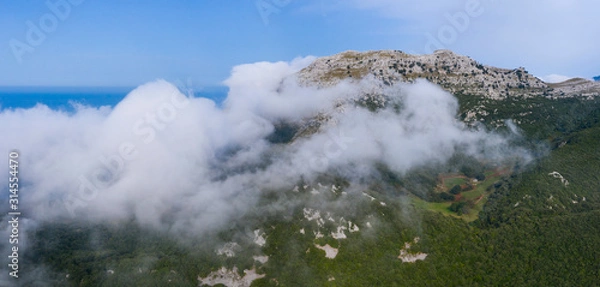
[0, 87, 228, 112]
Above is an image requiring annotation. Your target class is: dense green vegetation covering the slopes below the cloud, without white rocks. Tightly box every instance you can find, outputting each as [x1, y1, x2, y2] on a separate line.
[24, 95, 600, 286]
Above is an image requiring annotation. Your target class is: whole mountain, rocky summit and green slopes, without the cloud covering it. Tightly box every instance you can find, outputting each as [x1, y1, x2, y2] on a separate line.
[18, 51, 600, 286]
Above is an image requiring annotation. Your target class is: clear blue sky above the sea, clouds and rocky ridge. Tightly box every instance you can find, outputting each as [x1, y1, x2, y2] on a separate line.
[0, 0, 600, 87]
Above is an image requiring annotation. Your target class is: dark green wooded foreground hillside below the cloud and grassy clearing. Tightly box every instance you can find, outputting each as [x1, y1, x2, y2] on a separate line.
[24, 121, 600, 286]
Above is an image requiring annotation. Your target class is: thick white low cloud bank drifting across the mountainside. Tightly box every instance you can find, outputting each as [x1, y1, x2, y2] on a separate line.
[0, 58, 528, 234]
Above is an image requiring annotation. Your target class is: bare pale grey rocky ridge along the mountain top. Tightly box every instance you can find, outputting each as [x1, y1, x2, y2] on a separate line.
[298, 50, 600, 99]
